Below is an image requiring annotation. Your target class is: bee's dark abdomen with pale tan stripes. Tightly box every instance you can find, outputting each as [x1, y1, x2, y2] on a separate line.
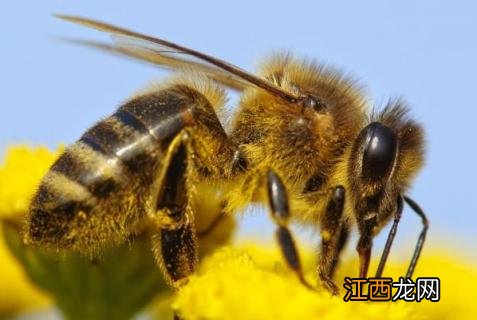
[28, 86, 204, 249]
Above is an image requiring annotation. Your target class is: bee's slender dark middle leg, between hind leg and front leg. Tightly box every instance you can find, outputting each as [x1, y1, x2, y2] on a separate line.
[267, 170, 314, 290]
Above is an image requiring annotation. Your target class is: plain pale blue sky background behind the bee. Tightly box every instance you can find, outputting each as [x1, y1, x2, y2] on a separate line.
[0, 0, 477, 257]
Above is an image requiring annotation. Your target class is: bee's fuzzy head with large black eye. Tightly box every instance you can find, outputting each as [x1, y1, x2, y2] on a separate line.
[348, 101, 424, 212]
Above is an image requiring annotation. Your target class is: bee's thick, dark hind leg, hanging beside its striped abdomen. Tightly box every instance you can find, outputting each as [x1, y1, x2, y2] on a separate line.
[149, 134, 198, 288]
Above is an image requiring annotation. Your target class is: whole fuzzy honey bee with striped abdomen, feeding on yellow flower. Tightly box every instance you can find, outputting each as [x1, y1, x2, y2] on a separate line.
[25, 15, 428, 294]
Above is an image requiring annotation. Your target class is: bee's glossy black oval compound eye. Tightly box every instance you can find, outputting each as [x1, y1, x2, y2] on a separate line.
[362, 122, 397, 180]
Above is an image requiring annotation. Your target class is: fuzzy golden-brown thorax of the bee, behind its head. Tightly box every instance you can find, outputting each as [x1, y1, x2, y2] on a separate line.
[232, 53, 366, 191]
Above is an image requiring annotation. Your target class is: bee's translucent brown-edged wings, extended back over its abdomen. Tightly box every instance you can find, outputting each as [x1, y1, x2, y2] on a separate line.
[57, 15, 300, 102]
